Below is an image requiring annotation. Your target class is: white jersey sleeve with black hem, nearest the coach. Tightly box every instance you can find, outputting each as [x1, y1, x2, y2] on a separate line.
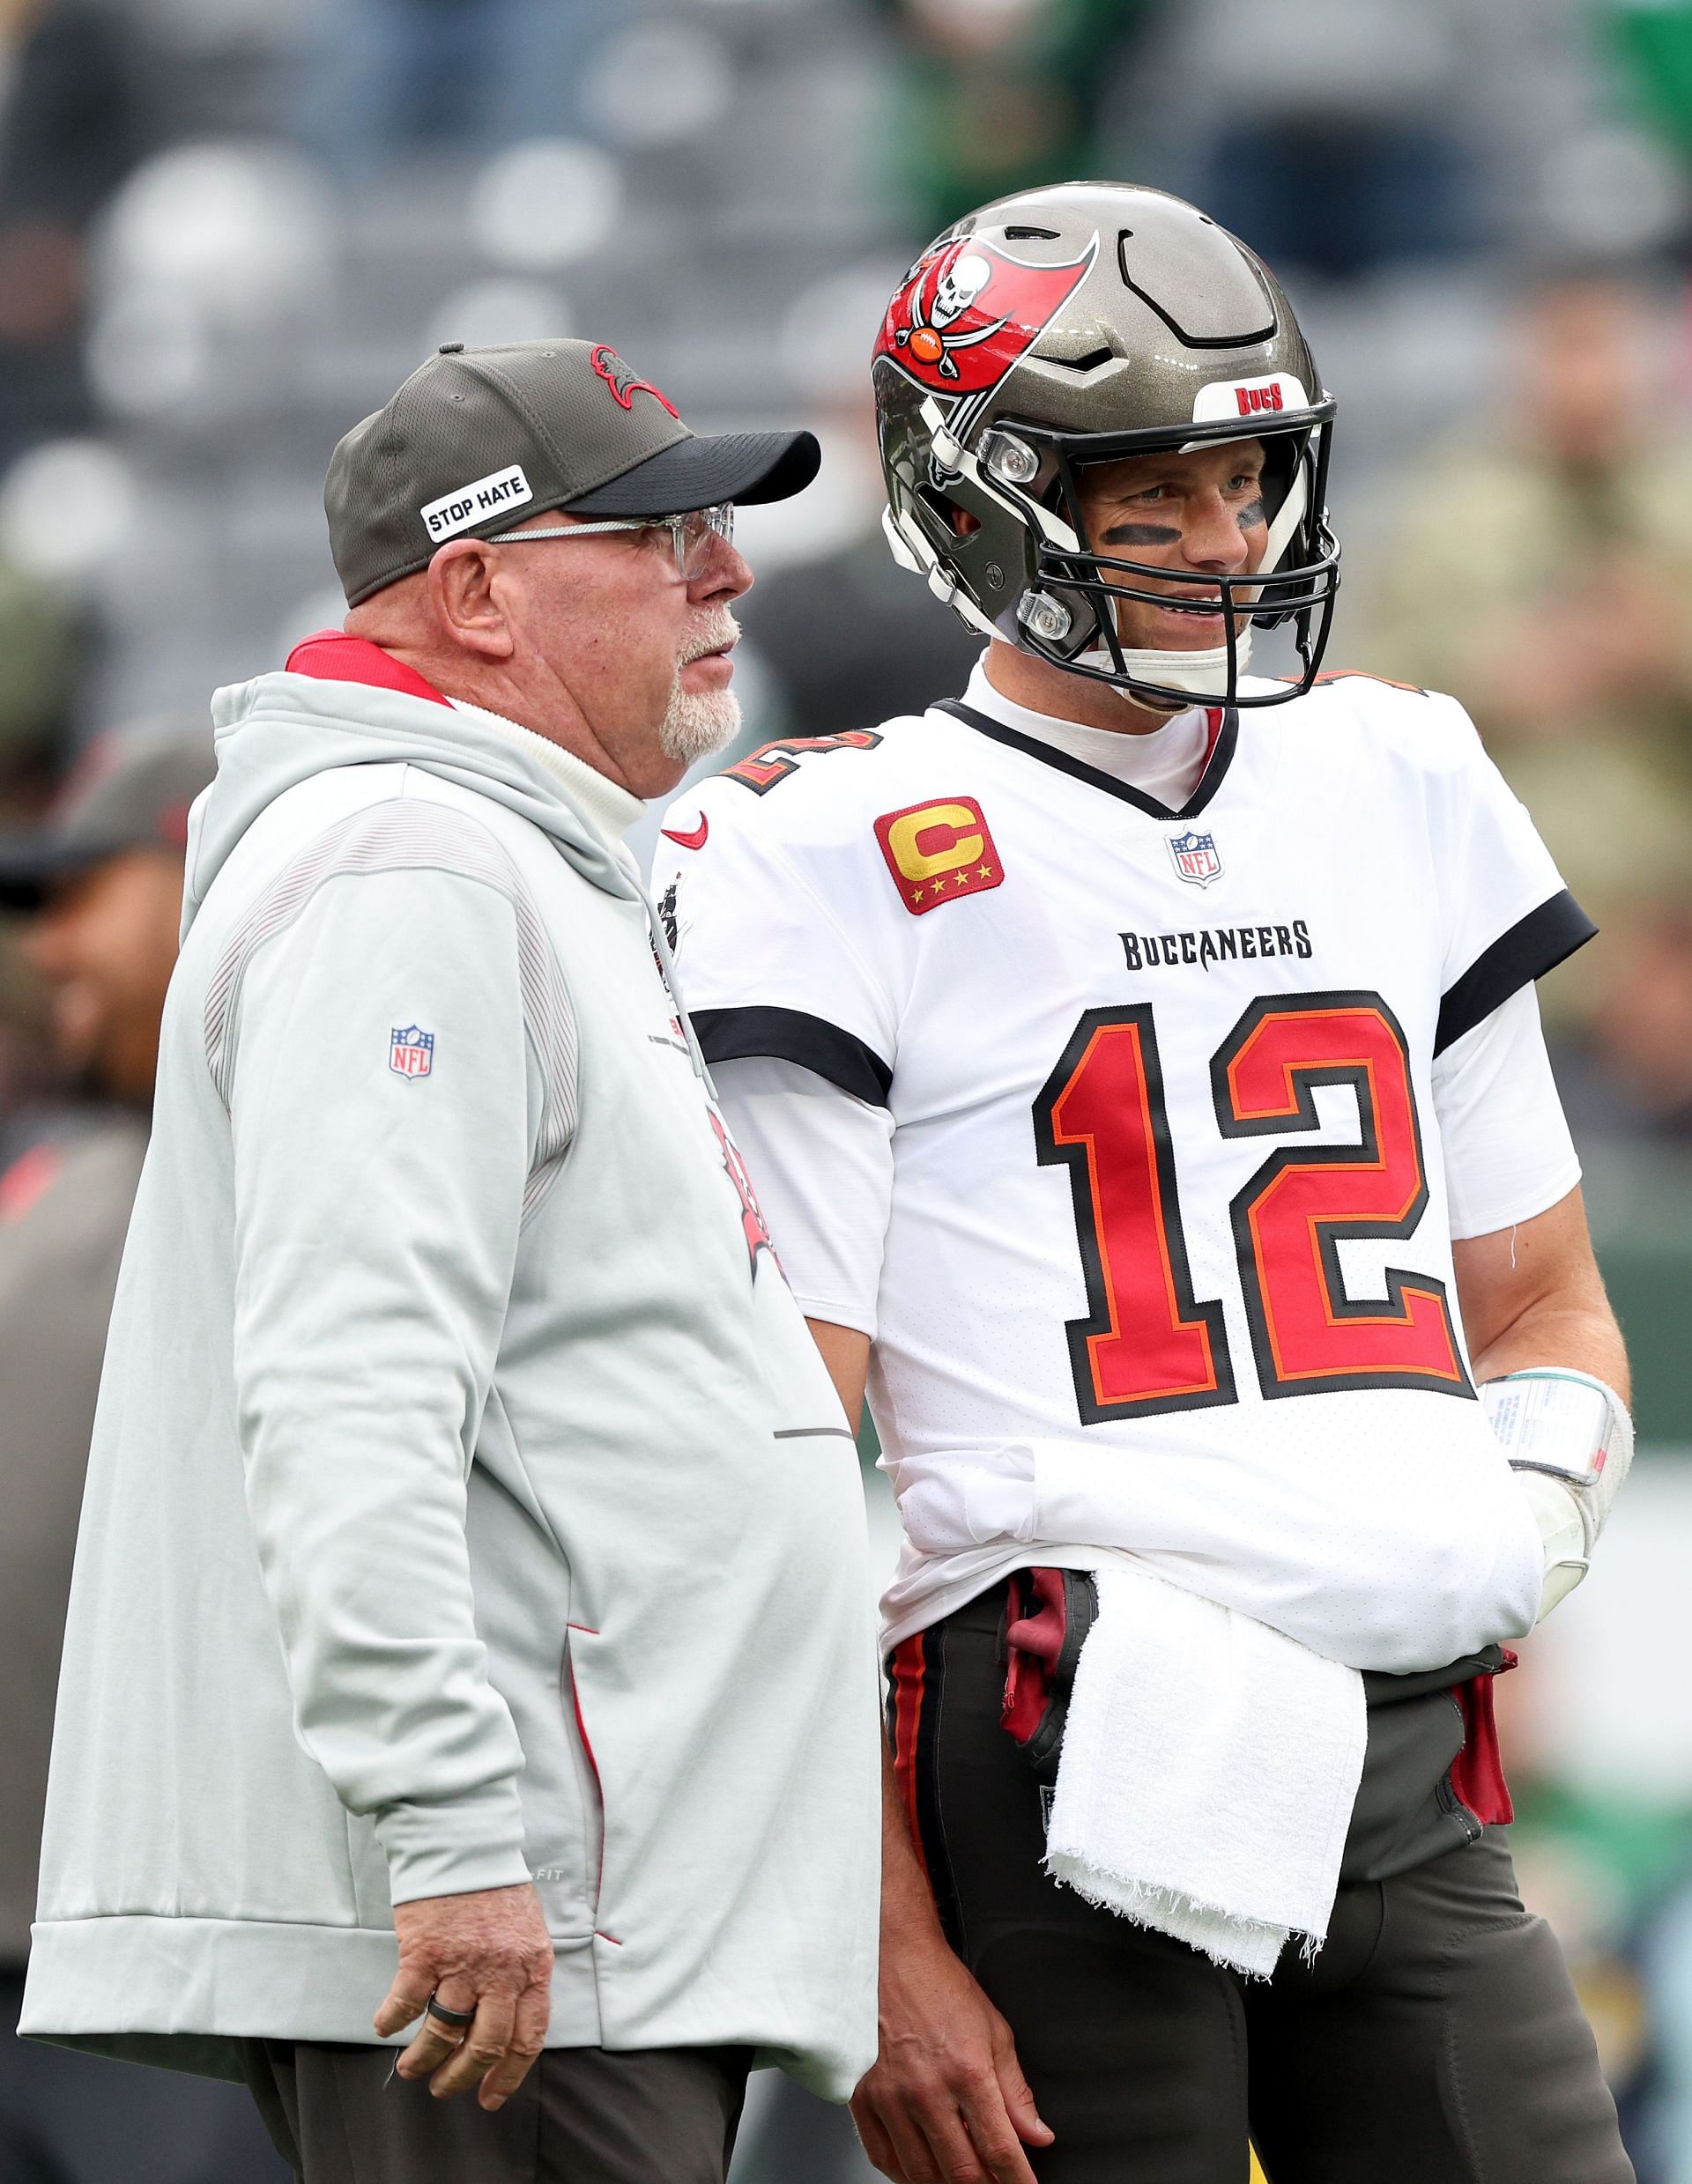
[653, 806, 900, 1107]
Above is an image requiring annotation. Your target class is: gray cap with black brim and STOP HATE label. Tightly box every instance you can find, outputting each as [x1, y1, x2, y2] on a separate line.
[323, 338, 821, 607]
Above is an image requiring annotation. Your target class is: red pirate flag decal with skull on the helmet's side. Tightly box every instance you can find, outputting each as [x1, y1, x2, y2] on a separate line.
[875, 236, 1098, 396]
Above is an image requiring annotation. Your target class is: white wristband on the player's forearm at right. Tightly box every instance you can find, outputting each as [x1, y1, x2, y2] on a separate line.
[1480, 1365, 1633, 1623]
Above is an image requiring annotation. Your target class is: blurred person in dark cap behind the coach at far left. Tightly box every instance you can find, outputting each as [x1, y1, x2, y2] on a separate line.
[0, 729, 284, 2184]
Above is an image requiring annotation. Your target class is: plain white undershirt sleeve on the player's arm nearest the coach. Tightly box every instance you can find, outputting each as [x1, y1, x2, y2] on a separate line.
[712, 1055, 893, 1341]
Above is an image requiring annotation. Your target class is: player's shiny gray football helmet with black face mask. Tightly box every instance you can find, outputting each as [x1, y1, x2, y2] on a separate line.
[871, 181, 1339, 706]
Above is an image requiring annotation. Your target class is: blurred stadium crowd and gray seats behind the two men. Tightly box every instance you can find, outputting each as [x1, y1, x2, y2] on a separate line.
[0, 0, 1692, 2184]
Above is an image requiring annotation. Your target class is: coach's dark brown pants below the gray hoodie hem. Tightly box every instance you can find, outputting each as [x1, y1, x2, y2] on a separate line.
[247, 2040, 751, 2184]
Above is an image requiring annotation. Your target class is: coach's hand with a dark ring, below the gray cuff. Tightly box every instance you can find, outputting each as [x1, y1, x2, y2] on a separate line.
[375, 1883, 553, 2107]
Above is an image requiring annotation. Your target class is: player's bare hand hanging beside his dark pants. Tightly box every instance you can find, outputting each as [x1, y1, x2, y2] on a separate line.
[851, 1906, 1052, 2184]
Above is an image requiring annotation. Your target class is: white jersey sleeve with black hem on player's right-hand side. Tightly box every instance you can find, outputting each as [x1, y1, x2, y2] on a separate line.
[1435, 699, 1598, 1055]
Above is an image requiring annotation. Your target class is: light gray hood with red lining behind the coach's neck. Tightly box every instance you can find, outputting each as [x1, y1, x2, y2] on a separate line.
[182, 629, 644, 937]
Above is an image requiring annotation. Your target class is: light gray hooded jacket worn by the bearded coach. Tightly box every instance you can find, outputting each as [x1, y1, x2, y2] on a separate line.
[22, 638, 878, 2097]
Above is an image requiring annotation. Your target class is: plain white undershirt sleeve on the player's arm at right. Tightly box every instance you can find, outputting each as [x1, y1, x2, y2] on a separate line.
[1435, 985, 1581, 1236]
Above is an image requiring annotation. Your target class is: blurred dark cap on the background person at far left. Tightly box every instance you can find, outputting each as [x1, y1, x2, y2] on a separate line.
[0, 723, 216, 911]
